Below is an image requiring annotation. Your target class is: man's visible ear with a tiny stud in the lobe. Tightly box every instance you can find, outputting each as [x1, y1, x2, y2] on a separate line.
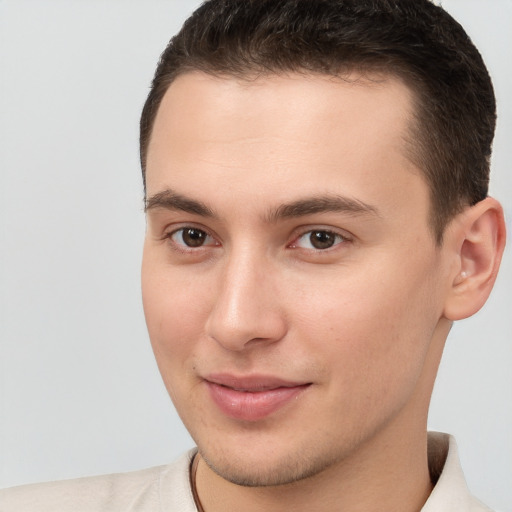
[444, 197, 505, 321]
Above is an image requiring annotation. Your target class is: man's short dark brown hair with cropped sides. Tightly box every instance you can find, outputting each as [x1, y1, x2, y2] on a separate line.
[140, 0, 496, 243]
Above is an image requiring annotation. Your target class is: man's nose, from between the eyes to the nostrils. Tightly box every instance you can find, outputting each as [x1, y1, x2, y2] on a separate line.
[206, 251, 287, 351]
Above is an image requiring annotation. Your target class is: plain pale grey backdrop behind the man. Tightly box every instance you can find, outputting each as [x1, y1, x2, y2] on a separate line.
[0, 0, 512, 512]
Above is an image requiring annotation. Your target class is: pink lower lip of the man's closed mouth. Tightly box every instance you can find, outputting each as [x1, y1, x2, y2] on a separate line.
[206, 381, 309, 421]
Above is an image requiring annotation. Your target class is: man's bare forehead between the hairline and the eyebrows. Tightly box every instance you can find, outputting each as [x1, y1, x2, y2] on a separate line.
[146, 72, 425, 220]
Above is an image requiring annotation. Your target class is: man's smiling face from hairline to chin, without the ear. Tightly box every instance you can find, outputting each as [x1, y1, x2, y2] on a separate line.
[142, 72, 447, 485]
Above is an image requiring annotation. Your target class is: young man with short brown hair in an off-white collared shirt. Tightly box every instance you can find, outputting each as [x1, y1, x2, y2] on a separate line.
[0, 0, 505, 512]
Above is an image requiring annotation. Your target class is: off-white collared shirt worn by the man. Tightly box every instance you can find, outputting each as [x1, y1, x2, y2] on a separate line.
[0, 433, 491, 512]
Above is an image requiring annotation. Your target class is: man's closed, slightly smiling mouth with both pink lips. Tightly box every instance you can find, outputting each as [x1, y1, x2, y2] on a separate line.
[204, 374, 311, 422]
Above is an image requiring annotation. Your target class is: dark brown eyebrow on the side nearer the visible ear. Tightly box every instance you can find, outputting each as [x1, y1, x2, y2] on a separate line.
[267, 195, 379, 222]
